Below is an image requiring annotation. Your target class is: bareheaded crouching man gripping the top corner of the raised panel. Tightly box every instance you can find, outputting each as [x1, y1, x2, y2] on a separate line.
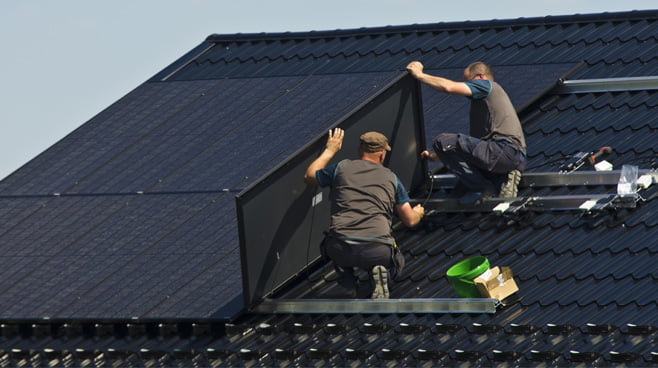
[407, 61, 527, 202]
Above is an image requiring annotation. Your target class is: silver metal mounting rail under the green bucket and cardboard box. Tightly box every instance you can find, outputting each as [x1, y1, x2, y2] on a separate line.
[252, 298, 500, 314]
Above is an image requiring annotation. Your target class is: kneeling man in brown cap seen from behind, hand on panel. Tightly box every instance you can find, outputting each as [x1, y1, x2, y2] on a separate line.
[304, 128, 425, 299]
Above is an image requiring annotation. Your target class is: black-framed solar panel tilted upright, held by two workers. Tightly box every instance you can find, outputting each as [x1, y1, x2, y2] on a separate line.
[236, 73, 427, 308]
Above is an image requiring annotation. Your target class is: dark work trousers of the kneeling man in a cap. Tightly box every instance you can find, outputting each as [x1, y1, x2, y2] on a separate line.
[321, 236, 404, 288]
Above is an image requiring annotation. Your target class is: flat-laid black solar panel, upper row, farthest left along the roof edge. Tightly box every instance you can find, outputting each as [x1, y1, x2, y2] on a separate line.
[0, 81, 217, 195]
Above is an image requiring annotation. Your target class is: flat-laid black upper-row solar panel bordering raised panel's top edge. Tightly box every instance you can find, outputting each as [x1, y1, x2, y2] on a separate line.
[154, 73, 398, 191]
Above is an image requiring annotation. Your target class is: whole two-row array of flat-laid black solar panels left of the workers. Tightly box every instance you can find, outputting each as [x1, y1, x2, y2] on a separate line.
[0, 73, 394, 319]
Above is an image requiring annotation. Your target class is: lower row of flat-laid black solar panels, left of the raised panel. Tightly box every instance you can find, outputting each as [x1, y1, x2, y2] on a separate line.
[0, 192, 241, 318]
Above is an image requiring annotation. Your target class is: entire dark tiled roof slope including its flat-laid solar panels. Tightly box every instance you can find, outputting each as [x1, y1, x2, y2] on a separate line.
[0, 11, 658, 366]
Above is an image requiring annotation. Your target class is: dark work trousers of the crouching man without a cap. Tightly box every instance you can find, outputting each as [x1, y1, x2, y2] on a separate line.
[433, 133, 526, 195]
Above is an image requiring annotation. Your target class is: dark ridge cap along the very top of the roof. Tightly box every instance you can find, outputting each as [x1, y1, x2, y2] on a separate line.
[206, 10, 658, 42]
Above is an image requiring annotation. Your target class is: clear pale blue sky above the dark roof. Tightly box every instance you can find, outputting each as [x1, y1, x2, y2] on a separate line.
[0, 0, 658, 179]
